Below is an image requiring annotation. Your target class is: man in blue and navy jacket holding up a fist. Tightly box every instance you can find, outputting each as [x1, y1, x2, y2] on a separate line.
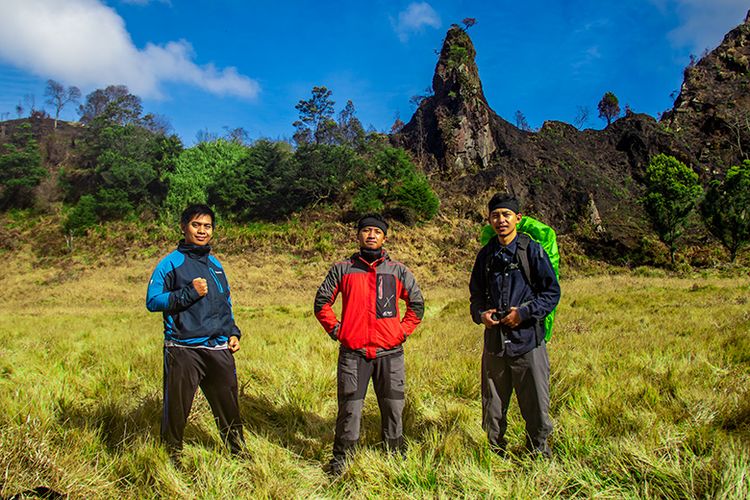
[146, 205, 244, 459]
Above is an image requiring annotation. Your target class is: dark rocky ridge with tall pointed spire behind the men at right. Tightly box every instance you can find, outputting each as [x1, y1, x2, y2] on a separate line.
[392, 16, 750, 247]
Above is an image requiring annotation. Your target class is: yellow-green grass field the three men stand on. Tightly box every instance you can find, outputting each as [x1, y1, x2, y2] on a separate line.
[0, 248, 750, 498]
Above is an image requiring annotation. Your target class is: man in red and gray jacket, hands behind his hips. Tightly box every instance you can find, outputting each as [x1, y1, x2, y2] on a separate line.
[315, 214, 424, 475]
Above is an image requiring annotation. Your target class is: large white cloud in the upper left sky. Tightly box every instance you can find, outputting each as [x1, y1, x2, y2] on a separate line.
[0, 0, 260, 98]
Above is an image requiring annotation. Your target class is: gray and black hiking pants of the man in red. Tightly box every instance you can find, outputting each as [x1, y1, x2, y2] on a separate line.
[333, 348, 405, 460]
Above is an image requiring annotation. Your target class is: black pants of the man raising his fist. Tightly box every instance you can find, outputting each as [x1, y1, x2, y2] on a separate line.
[161, 347, 244, 453]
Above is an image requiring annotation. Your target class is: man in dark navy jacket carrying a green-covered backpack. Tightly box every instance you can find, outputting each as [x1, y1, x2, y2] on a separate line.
[469, 193, 560, 457]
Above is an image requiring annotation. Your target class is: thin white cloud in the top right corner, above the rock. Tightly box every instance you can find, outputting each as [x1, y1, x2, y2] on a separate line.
[668, 0, 750, 55]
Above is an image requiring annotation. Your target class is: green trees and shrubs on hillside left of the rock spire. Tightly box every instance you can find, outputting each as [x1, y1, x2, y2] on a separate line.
[0, 85, 439, 239]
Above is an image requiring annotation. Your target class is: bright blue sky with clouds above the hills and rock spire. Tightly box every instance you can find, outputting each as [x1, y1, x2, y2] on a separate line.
[0, 0, 750, 145]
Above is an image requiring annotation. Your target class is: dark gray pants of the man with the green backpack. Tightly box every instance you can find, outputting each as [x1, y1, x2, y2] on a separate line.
[482, 342, 552, 456]
